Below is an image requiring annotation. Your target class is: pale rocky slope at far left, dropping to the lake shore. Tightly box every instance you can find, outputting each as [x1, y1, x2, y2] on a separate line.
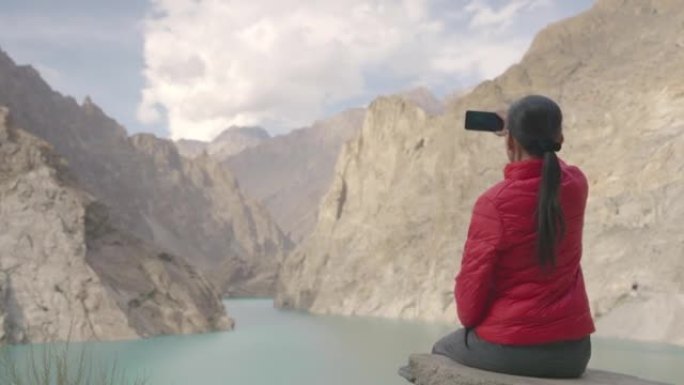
[0, 107, 232, 344]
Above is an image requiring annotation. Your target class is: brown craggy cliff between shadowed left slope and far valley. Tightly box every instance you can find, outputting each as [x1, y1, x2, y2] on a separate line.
[129, 134, 290, 296]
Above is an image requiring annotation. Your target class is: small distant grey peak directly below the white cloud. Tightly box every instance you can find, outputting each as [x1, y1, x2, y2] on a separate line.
[176, 126, 271, 162]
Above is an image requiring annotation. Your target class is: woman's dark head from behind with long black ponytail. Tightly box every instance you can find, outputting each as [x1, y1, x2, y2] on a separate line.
[507, 95, 565, 268]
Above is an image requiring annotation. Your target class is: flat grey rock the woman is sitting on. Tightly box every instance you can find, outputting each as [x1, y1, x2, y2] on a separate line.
[409, 354, 665, 385]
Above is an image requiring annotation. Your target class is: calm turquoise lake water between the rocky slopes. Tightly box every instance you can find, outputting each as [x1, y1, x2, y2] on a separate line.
[1, 300, 684, 385]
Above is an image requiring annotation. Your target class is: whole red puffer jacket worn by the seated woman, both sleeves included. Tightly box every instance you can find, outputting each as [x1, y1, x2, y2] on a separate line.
[455, 159, 594, 345]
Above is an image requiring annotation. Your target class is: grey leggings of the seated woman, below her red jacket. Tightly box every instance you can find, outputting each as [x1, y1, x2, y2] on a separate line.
[432, 329, 591, 378]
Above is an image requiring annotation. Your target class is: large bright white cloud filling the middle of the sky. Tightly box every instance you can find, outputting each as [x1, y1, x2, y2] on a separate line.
[138, 0, 576, 140]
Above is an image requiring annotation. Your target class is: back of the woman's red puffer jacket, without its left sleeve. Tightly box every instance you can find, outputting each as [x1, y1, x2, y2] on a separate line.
[472, 159, 594, 345]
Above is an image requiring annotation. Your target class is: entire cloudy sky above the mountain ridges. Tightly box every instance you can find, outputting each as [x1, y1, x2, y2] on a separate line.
[0, 0, 593, 140]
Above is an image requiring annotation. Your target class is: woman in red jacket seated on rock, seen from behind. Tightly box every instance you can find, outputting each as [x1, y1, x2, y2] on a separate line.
[433, 95, 594, 378]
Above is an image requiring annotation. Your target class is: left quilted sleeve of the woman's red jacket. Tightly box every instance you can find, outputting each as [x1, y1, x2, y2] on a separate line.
[454, 196, 502, 328]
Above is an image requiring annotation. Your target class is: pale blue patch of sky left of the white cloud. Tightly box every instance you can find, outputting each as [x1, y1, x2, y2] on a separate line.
[0, 0, 158, 135]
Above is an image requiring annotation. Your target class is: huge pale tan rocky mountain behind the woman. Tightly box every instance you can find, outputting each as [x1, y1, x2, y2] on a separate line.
[277, 0, 684, 344]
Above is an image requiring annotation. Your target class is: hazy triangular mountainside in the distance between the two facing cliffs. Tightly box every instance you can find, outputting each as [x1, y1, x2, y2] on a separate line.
[225, 108, 365, 242]
